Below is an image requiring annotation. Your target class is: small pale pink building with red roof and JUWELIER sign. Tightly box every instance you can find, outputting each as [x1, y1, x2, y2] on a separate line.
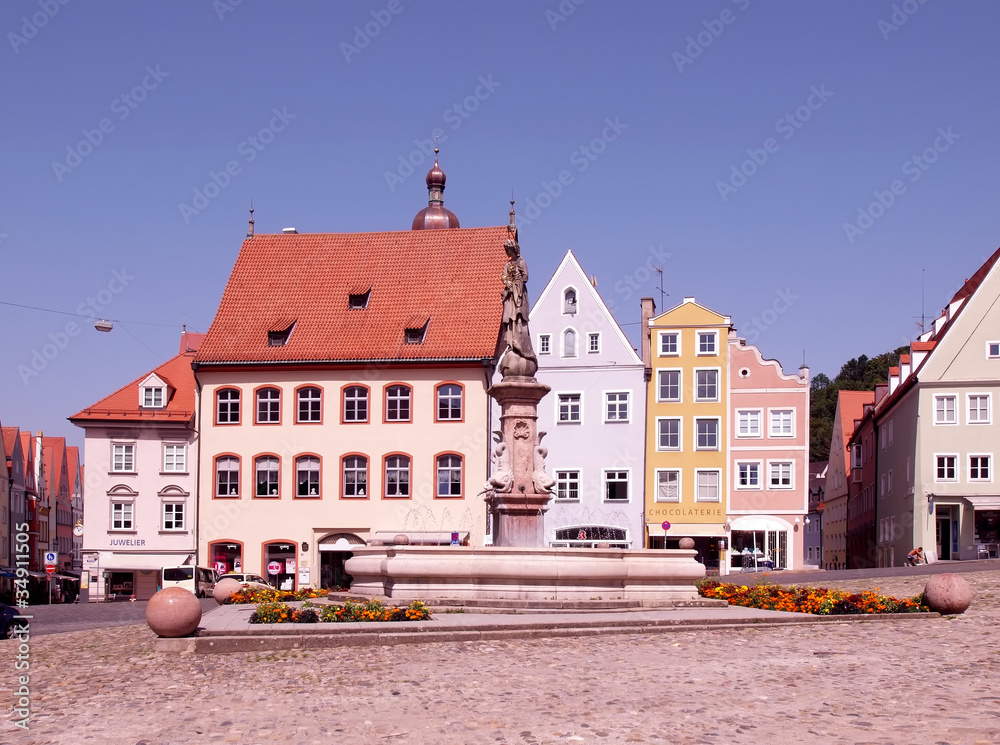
[70, 352, 197, 600]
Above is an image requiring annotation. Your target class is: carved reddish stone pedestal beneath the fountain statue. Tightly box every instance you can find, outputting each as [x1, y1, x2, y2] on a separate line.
[489, 375, 552, 547]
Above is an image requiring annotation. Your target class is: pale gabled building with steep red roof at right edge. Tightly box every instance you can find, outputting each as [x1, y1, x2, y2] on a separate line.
[874, 249, 1000, 566]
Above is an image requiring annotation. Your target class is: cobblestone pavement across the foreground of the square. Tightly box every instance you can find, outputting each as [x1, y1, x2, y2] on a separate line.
[0, 571, 1000, 745]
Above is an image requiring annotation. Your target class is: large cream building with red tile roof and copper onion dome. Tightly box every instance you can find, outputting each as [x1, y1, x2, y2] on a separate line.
[195, 167, 509, 587]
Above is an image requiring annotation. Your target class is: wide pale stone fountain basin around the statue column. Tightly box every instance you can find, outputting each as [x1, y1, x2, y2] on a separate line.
[344, 546, 705, 602]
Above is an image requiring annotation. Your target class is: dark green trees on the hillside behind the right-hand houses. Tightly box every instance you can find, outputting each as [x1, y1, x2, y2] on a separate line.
[809, 346, 910, 462]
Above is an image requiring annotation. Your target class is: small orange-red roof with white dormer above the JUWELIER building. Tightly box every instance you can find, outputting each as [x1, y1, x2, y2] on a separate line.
[69, 352, 195, 424]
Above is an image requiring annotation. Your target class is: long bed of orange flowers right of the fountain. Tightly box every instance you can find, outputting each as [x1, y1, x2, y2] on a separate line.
[698, 580, 930, 616]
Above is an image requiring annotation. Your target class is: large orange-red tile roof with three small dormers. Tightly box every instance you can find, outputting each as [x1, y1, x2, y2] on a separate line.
[196, 226, 509, 365]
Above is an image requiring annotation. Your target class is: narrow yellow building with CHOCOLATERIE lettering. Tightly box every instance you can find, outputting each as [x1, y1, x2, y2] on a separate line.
[642, 297, 732, 566]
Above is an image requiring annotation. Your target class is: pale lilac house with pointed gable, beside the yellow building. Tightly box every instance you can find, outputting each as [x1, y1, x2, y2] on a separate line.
[528, 251, 646, 548]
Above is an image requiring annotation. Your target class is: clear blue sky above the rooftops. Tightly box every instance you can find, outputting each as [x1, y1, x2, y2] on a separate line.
[0, 0, 1000, 444]
